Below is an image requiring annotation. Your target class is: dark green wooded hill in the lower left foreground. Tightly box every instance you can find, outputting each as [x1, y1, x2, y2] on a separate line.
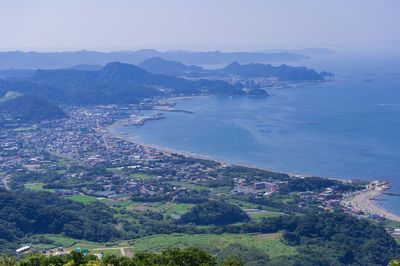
[0, 189, 119, 252]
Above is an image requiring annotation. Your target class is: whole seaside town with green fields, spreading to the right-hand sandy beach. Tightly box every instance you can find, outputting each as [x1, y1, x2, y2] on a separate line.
[0, 104, 400, 256]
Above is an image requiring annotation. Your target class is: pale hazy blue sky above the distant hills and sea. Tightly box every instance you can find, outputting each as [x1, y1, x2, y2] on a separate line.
[0, 0, 400, 51]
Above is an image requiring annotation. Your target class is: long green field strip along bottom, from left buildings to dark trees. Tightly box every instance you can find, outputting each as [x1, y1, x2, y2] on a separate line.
[26, 233, 296, 258]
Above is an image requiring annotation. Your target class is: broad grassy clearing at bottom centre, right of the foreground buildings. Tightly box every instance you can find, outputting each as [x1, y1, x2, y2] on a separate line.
[130, 234, 296, 257]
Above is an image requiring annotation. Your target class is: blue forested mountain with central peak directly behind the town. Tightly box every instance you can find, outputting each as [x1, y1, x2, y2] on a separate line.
[0, 62, 245, 108]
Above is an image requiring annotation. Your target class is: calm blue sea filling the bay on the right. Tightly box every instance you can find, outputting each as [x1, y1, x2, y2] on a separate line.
[112, 53, 400, 215]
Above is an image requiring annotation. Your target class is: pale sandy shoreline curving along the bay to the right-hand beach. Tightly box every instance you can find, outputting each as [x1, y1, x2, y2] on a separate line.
[102, 121, 400, 222]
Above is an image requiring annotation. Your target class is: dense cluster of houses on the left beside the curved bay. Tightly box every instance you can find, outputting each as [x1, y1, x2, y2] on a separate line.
[0, 106, 248, 202]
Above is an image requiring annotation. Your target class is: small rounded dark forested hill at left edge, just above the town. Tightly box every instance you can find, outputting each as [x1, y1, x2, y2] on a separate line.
[0, 94, 66, 122]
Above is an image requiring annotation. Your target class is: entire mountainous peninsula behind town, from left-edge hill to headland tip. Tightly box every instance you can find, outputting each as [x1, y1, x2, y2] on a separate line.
[0, 57, 331, 122]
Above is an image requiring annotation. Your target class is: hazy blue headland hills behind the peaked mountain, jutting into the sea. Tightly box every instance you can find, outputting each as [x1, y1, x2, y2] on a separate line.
[139, 57, 328, 81]
